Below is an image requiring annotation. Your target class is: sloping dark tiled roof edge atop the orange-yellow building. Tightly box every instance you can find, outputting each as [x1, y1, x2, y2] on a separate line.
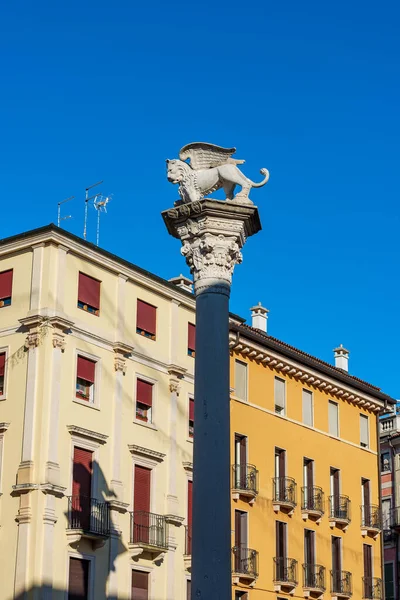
[230, 323, 396, 404]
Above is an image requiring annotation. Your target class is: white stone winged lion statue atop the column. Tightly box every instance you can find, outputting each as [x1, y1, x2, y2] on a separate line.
[167, 142, 269, 204]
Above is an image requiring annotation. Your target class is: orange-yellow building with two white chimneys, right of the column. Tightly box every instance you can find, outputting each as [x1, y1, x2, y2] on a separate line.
[230, 316, 394, 600]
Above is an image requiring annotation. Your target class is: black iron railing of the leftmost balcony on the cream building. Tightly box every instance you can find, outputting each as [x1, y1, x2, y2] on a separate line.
[68, 496, 110, 536]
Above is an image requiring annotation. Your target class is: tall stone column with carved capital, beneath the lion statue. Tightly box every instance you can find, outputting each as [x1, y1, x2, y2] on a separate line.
[162, 198, 261, 600]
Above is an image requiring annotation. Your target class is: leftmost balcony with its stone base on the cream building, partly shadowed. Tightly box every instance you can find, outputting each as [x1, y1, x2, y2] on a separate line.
[67, 496, 110, 549]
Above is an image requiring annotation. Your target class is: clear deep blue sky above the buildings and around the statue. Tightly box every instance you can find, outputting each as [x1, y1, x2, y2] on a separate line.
[0, 0, 400, 397]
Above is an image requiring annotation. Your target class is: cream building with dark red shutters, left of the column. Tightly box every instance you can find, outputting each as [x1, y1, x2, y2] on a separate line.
[0, 225, 194, 600]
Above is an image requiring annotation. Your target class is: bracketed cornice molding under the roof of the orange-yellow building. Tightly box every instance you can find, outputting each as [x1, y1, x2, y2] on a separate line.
[229, 333, 382, 413]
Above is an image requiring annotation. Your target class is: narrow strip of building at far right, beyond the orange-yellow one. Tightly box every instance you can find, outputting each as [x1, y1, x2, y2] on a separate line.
[380, 403, 400, 600]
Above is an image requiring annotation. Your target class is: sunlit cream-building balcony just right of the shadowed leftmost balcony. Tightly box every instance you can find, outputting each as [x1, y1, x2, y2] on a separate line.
[129, 511, 168, 562]
